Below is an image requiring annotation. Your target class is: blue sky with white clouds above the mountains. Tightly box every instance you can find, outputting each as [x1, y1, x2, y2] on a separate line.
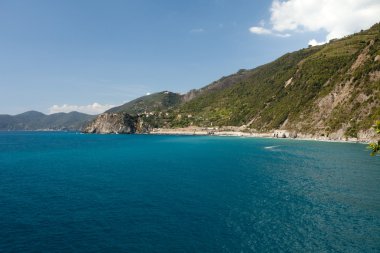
[0, 0, 380, 115]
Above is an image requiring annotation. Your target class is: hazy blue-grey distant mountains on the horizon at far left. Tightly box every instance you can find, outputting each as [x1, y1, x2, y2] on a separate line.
[0, 111, 96, 131]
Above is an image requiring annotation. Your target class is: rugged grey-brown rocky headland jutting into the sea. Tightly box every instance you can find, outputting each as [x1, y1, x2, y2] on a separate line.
[83, 113, 149, 134]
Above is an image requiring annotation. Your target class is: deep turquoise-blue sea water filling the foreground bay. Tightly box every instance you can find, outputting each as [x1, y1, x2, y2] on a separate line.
[0, 132, 380, 252]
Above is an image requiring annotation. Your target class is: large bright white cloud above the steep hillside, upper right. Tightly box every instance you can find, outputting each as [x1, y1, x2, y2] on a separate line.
[250, 0, 380, 44]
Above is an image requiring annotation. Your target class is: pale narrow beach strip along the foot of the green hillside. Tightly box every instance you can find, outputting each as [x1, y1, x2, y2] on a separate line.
[148, 128, 375, 144]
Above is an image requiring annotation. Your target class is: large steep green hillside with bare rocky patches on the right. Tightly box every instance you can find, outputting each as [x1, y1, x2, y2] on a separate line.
[171, 24, 380, 137]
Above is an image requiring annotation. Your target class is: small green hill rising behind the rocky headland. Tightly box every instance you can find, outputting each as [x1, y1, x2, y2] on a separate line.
[106, 91, 182, 115]
